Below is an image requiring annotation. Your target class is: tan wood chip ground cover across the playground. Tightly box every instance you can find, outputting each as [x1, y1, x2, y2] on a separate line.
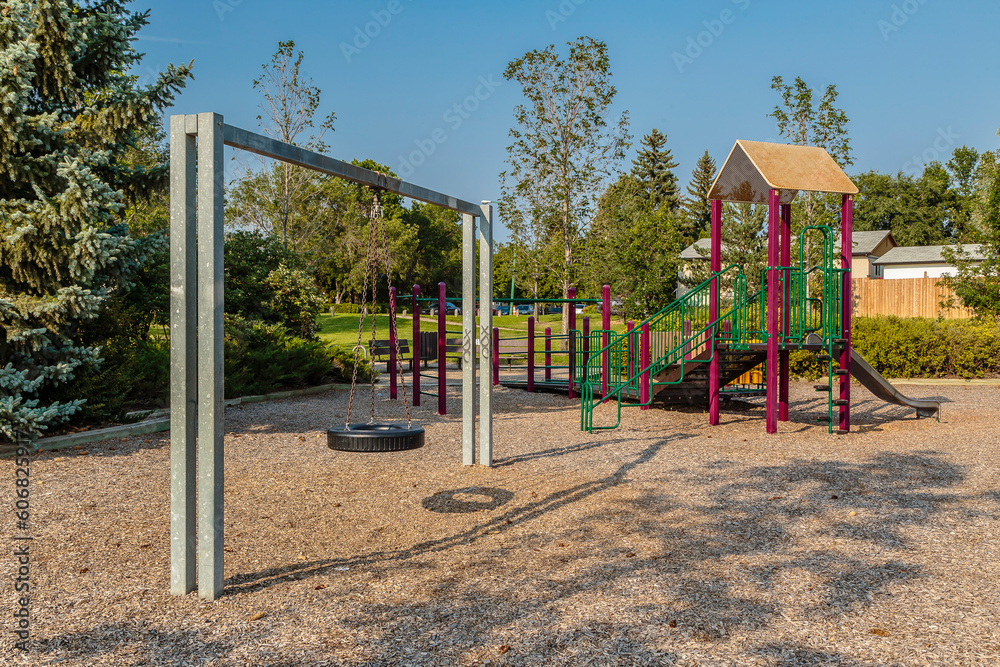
[0, 383, 1000, 666]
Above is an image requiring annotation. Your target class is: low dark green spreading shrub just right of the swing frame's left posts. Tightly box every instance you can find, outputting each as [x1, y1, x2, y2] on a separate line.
[225, 315, 372, 398]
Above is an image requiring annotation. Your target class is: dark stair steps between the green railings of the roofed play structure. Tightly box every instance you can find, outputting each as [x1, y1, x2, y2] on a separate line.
[651, 346, 767, 405]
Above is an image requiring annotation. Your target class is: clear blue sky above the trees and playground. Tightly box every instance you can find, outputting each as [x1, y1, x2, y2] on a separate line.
[132, 0, 1000, 239]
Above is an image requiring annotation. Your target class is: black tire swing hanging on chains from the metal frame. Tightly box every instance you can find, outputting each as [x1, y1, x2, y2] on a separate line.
[326, 184, 424, 452]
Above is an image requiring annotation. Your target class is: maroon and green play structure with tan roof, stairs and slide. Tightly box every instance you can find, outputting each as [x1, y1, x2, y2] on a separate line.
[574, 141, 940, 433]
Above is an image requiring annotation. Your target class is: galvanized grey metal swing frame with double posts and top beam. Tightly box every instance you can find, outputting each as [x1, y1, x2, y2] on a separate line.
[169, 113, 493, 600]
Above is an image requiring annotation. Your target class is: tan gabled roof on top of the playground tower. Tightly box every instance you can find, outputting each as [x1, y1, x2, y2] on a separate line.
[708, 139, 858, 204]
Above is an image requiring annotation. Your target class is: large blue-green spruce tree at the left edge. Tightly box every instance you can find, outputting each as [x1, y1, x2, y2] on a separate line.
[0, 0, 190, 444]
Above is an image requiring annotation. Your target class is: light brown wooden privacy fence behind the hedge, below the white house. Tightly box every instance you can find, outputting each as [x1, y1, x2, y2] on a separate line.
[851, 278, 973, 320]
